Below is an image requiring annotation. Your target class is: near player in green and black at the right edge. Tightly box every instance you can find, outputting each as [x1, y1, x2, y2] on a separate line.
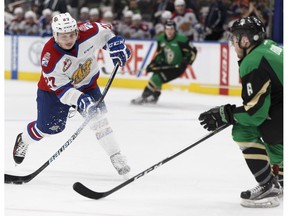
[199, 16, 283, 207]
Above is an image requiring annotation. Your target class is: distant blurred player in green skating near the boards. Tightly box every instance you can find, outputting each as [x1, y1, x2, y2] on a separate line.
[131, 20, 197, 104]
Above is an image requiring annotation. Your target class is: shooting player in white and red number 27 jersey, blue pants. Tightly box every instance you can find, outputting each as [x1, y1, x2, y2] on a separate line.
[13, 13, 130, 175]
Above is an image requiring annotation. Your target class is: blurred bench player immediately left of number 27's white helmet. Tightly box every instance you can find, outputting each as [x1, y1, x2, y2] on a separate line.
[39, 8, 52, 37]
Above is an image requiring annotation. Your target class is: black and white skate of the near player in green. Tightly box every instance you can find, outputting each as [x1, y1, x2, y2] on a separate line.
[241, 178, 281, 208]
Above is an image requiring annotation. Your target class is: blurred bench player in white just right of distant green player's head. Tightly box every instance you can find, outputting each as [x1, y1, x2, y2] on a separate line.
[172, 0, 198, 40]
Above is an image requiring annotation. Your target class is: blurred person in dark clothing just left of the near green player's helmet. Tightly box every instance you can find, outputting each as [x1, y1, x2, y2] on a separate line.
[205, 0, 227, 41]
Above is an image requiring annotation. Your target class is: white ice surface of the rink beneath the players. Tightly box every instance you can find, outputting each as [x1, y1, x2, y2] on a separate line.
[4, 80, 284, 216]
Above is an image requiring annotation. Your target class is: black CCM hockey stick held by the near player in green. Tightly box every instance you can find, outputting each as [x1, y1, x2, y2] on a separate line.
[73, 124, 229, 200]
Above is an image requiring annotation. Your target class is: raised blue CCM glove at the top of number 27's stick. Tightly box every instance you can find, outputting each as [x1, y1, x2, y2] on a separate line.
[104, 36, 131, 67]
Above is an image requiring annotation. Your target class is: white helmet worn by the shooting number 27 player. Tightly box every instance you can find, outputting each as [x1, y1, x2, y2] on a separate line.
[51, 13, 78, 36]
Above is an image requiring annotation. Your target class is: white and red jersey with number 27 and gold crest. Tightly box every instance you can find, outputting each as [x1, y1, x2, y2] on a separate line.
[38, 22, 115, 106]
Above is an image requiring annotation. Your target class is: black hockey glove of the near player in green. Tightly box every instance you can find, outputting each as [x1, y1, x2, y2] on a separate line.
[198, 104, 236, 131]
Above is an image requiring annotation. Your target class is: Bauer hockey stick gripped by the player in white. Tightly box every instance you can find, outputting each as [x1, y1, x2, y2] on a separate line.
[4, 64, 119, 184]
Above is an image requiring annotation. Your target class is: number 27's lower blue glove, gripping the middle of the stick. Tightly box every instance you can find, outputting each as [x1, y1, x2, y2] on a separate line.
[77, 94, 97, 118]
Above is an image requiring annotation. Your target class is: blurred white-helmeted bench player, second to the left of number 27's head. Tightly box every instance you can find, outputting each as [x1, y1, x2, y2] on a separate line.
[21, 10, 39, 35]
